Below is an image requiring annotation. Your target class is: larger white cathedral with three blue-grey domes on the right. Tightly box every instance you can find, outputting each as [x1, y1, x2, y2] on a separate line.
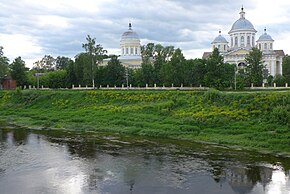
[203, 8, 285, 76]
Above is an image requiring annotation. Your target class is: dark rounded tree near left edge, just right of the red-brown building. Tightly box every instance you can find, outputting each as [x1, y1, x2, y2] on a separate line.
[9, 57, 28, 86]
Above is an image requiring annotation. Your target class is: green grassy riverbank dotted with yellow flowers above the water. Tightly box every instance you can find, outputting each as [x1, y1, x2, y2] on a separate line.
[0, 90, 290, 154]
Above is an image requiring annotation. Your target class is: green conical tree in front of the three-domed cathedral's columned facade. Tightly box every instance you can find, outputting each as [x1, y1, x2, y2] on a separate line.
[245, 48, 265, 86]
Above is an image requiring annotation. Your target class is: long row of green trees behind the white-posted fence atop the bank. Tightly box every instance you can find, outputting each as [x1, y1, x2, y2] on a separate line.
[0, 36, 290, 89]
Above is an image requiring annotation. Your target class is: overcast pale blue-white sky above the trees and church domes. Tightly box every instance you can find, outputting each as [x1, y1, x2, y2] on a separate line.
[0, 0, 290, 67]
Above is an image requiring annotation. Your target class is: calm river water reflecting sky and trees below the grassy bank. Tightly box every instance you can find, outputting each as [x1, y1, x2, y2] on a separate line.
[0, 127, 290, 194]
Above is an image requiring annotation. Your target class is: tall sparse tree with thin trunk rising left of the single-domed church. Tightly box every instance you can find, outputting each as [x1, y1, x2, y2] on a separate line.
[82, 35, 107, 87]
